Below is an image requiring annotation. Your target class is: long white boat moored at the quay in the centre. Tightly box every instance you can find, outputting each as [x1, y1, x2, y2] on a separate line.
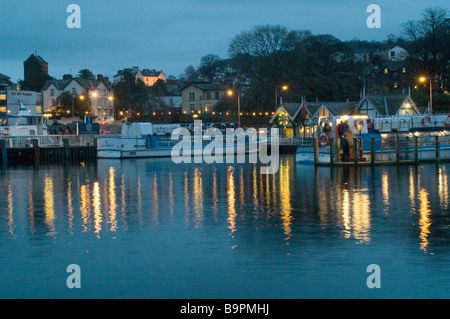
[97, 123, 257, 158]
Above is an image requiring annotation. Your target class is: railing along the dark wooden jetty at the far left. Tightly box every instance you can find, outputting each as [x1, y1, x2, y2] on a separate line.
[0, 135, 96, 148]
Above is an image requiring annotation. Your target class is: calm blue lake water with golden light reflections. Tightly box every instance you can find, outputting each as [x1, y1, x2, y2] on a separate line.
[0, 155, 450, 299]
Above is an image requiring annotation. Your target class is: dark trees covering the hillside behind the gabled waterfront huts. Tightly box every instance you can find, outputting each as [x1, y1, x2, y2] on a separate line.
[181, 8, 450, 110]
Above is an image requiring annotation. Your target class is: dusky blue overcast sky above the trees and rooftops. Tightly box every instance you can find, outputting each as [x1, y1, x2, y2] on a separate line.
[0, 0, 449, 81]
